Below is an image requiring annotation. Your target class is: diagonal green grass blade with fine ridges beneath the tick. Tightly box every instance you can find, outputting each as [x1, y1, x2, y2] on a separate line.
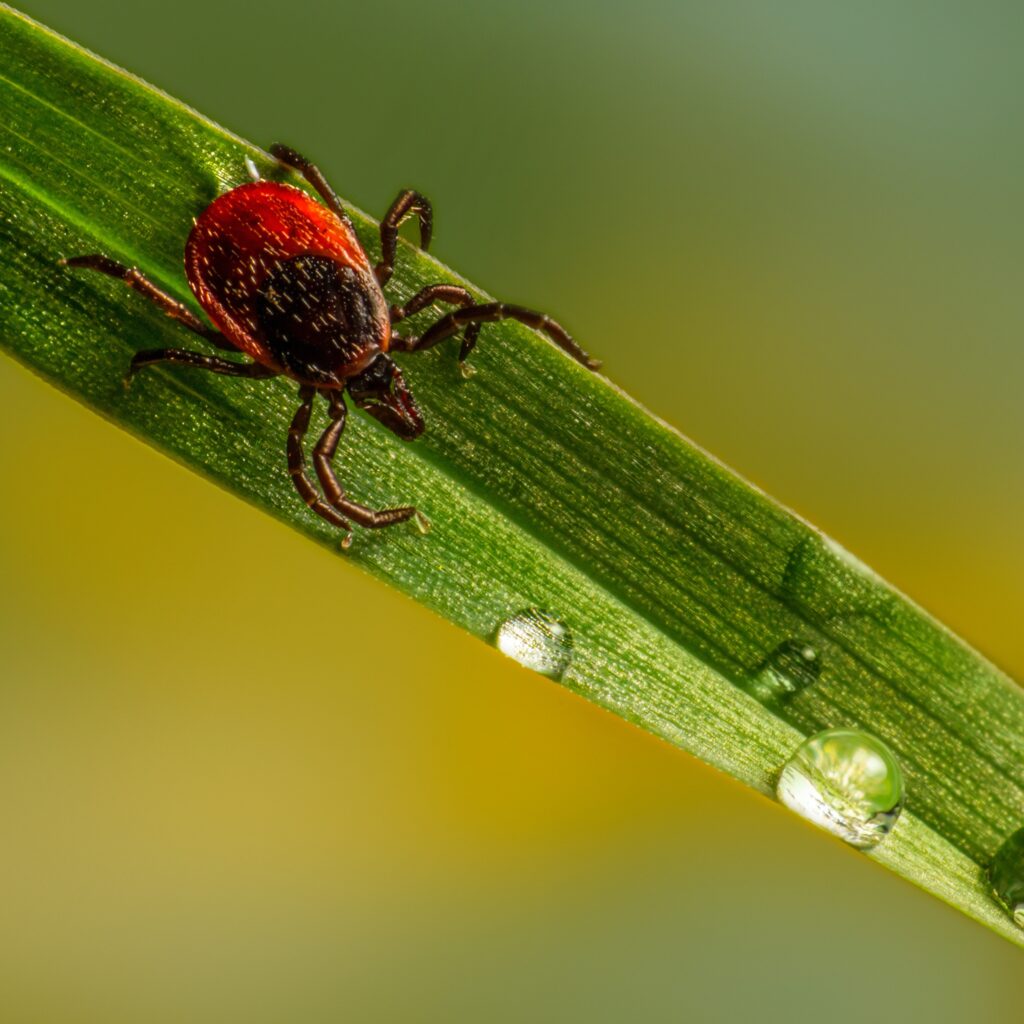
[0, 7, 1024, 944]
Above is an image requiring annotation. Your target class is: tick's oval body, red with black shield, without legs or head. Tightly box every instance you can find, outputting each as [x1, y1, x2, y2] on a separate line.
[185, 181, 390, 386]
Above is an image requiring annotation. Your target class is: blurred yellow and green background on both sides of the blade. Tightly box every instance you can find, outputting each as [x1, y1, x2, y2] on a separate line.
[0, 0, 1024, 1024]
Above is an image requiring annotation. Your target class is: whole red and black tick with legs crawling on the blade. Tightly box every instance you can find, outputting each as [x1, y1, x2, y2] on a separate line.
[62, 145, 600, 547]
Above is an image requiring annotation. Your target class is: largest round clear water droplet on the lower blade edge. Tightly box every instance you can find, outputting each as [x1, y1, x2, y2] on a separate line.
[775, 729, 903, 850]
